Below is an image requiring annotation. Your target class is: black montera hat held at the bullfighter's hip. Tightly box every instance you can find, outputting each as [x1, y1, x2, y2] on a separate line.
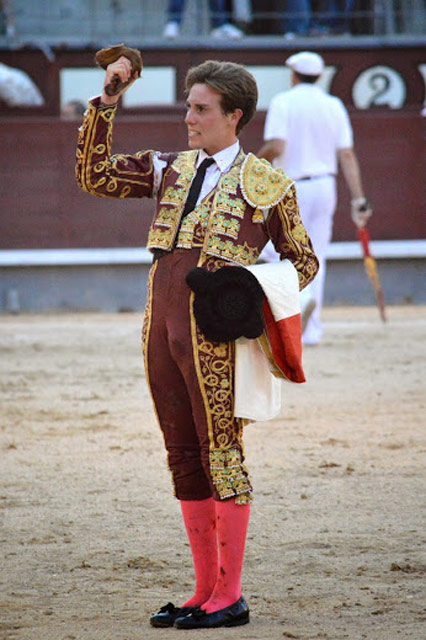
[186, 267, 265, 342]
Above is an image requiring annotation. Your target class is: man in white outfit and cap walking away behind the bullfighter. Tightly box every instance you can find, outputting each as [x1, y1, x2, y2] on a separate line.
[257, 51, 371, 344]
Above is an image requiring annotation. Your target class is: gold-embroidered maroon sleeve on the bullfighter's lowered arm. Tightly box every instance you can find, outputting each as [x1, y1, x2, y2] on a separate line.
[266, 185, 319, 289]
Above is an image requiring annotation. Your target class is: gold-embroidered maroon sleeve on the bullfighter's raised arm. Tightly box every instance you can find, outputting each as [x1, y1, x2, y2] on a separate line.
[75, 98, 155, 198]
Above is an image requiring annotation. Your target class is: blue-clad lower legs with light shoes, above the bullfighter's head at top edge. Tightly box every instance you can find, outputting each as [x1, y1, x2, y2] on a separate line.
[163, 0, 244, 40]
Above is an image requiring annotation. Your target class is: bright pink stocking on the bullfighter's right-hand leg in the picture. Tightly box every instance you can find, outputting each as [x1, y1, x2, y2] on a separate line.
[202, 498, 250, 613]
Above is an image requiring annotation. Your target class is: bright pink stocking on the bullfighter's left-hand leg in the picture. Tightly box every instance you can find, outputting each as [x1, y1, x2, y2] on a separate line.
[180, 498, 218, 607]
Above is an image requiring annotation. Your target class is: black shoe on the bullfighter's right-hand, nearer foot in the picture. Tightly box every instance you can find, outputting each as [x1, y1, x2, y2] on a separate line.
[175, 596, 250, 629]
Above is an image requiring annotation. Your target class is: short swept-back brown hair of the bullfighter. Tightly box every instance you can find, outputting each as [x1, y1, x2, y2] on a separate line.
[185, 60, 257, 133]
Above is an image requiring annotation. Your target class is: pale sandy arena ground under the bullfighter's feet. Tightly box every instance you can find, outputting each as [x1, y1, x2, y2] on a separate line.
[0, 307, 426, 640]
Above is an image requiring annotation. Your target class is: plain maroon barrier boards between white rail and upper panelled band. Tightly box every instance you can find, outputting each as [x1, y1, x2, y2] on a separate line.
[0, 112, 425, 249]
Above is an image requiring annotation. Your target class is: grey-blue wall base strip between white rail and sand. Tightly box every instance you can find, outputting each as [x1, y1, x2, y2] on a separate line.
[0, 258, 426, 314]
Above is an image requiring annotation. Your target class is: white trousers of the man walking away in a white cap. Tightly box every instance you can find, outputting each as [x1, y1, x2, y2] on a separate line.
[261, 176, 337, 344]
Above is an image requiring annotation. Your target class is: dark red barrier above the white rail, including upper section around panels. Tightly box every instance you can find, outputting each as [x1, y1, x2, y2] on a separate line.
[0, 43, 426, 249]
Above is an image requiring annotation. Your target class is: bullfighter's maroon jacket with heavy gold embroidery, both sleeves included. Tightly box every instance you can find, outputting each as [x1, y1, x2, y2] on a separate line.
[76, 98, 318, 288]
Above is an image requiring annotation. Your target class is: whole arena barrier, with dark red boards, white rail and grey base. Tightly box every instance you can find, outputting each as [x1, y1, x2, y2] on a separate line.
[0, 41, 426, 311]
